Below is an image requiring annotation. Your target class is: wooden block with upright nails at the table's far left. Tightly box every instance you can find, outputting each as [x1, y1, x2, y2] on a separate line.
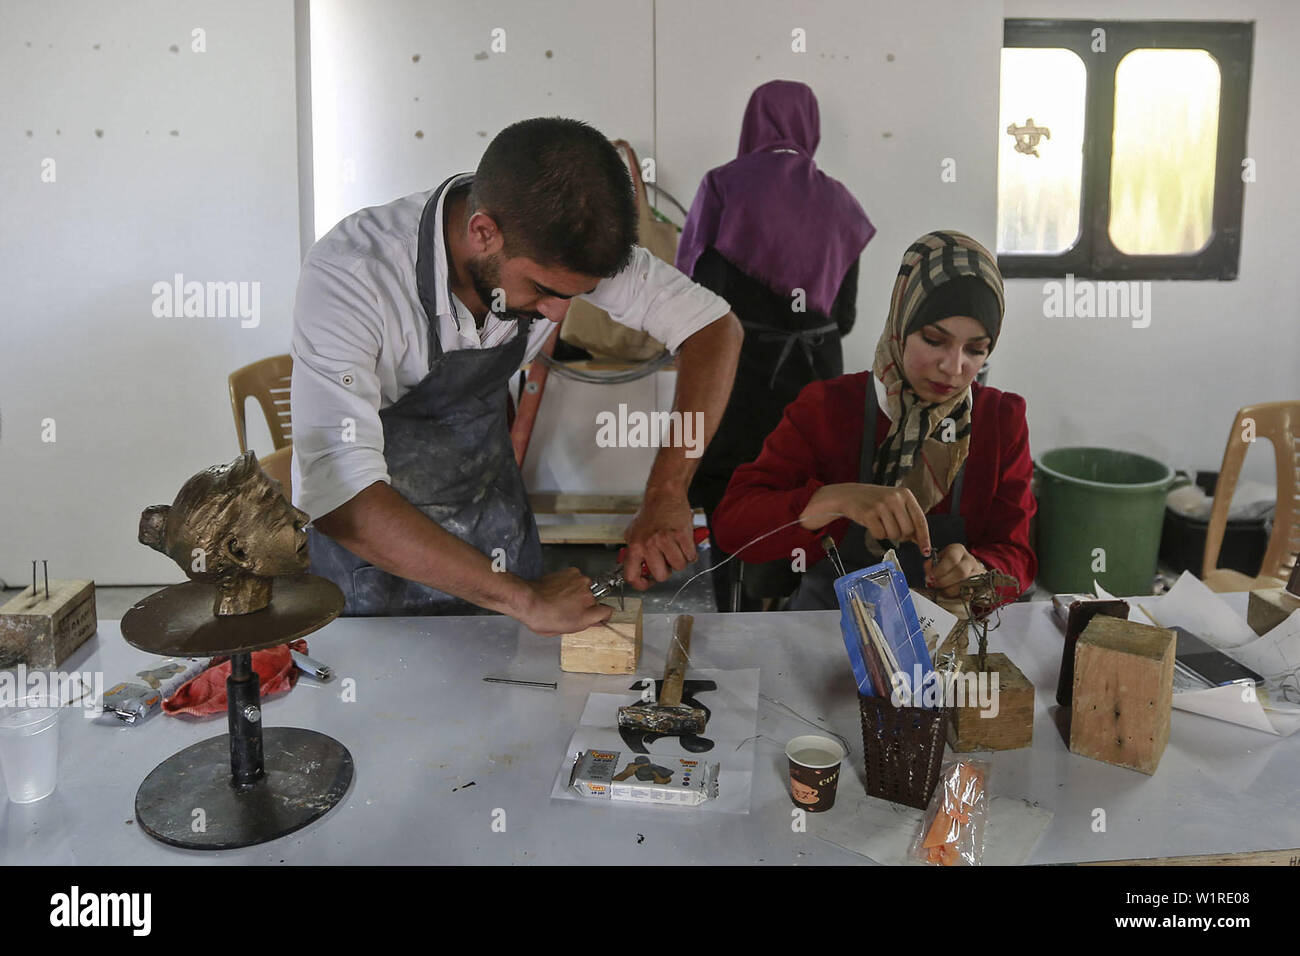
[0, 580, 98, 667]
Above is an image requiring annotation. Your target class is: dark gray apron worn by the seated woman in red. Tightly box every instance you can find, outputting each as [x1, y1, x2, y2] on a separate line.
[787, 375, 966, 611]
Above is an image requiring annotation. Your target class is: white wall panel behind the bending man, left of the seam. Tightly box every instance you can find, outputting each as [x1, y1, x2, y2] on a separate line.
[312, 0, 672, 493]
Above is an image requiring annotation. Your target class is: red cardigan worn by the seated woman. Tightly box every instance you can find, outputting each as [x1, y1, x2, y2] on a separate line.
[712, 372, 1039, 597]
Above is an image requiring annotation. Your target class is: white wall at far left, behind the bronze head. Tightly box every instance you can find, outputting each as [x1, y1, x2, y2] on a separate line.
[0, 0, 299, 584]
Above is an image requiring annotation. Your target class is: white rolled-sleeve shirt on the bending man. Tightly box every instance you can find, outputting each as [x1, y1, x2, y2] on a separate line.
[290, 176, 729, 528]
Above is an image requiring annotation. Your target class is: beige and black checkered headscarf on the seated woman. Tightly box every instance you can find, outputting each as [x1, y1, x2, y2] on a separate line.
[872, 229, 1005, 512]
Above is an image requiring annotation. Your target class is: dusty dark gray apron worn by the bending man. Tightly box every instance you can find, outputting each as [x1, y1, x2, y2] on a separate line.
[308, 177, 542, 617]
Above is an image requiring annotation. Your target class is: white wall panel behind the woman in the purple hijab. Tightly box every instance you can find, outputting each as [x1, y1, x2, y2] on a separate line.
[658, 0, 1002, 382]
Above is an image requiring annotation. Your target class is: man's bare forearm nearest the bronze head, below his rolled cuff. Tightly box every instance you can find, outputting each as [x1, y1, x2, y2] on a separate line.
[312, 481, 532, 618]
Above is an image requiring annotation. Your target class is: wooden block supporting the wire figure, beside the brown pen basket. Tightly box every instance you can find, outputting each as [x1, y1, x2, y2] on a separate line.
[948, 654, 1034, 753]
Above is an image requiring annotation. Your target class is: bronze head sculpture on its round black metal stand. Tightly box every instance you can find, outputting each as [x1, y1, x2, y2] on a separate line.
[122, 451, 352, 849]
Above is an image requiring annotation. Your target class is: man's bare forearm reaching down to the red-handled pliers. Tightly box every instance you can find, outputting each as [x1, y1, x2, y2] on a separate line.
[646, 312, 745, 498]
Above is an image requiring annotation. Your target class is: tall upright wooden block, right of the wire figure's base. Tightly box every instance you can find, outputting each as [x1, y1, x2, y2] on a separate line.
[1070, 614, 1177, 774]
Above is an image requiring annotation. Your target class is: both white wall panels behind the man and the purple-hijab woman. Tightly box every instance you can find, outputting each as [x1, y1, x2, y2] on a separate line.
[312, 0, 1002, 492]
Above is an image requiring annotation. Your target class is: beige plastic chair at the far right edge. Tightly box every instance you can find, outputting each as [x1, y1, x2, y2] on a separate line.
[1201, 402, 1300, 592]
